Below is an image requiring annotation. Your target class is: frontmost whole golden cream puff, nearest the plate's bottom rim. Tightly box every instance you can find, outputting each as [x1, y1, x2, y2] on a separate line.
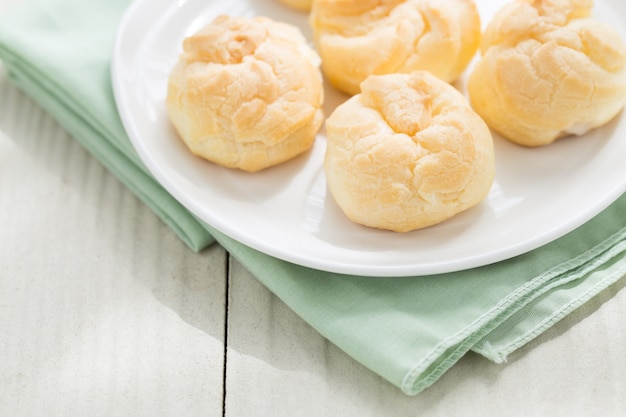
[324, 71, 495, 232]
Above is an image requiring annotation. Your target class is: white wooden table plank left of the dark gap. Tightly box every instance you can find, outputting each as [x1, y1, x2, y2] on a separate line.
[0, 67, 227, 417]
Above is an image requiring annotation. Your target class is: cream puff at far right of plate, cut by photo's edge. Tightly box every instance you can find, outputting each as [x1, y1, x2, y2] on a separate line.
[468, 0, 626, 146]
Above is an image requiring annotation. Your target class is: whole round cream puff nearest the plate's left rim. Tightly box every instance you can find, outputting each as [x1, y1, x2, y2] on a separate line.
[166, 16, 323, 172]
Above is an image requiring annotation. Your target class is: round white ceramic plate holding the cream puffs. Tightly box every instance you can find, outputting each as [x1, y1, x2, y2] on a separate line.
[112, 0, 626, 276]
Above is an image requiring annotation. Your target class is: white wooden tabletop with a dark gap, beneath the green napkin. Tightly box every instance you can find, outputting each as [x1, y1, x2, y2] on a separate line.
[0, 0, 626, 417]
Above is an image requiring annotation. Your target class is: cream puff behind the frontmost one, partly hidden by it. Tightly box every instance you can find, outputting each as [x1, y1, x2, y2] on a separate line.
[310, 0, 481, 94]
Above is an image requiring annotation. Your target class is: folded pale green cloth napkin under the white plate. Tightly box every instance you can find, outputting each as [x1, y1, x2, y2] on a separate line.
[0, 0, 626, 394]
